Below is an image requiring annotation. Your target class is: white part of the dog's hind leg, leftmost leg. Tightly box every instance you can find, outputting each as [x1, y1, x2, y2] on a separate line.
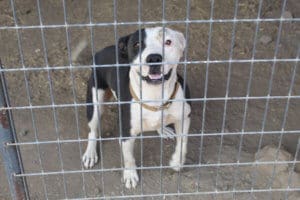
[82, 87, 105, 168]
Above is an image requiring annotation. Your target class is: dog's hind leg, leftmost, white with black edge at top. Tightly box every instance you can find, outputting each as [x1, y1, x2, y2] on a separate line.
[82, 87, 105, 168]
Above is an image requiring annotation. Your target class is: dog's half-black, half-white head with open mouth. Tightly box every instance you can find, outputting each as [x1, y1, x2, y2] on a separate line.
[118, 27, 185, 84]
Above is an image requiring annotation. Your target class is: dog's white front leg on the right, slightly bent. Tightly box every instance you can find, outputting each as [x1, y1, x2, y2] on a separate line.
[170, 117, 190, 171]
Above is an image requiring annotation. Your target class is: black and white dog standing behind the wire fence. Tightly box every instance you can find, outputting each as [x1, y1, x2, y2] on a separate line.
[82, 27, 191, 188]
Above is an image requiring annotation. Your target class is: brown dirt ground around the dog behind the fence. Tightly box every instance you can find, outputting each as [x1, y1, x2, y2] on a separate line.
[0, 0, 300, 200]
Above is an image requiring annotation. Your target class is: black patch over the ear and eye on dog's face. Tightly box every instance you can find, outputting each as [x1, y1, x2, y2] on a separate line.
[118, 29, 146, 63]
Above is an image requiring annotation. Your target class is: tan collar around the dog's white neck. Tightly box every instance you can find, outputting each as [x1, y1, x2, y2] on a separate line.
[129, 82, 179, 112]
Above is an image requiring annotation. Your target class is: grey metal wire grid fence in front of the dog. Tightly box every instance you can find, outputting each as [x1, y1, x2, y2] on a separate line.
[0, 0, 300, 199]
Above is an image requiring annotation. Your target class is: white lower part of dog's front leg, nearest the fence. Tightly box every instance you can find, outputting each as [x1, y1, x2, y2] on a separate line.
[122, 139, 139, 189]
